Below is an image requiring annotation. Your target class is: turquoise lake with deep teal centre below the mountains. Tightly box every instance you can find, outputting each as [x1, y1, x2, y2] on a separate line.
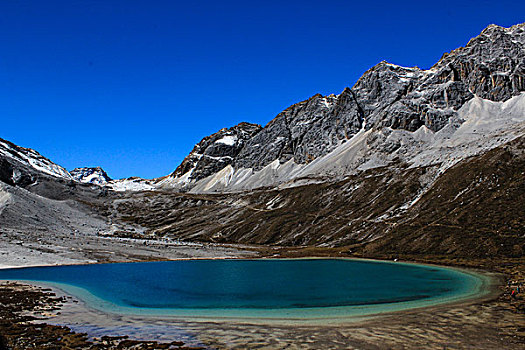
[0, 259, 482, 317]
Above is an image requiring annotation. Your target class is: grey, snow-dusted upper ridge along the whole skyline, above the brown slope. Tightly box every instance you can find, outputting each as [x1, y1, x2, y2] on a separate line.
[0, 23, 525, 197]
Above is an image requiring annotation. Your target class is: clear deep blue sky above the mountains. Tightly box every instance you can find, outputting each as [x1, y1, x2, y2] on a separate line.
[0, 0, 525, 178]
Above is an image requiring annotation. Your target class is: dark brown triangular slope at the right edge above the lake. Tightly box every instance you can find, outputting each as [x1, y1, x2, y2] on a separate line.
[366, 137, 525, 257]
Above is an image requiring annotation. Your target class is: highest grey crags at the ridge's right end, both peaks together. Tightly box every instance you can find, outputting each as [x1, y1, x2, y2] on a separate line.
[362, 24, 525, 131]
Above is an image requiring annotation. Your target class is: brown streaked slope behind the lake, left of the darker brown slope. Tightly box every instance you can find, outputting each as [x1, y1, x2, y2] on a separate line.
[114, 169, 426, 245]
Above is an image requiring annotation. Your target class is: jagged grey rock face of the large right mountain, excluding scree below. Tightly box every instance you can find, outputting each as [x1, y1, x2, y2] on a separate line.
[163, 24, 525, 188]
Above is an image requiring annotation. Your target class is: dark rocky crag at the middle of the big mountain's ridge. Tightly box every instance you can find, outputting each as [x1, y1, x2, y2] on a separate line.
[234, 89, 363, 170]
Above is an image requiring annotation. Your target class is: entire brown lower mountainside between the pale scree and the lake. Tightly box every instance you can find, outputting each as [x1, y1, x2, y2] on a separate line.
[112, 138, 525, 257]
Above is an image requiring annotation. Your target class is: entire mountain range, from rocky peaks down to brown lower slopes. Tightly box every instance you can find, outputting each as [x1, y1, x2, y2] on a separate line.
[0, 24, 525, 257]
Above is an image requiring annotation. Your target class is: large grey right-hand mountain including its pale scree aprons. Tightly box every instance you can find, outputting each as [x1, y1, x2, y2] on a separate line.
[166, 24, 525, 192]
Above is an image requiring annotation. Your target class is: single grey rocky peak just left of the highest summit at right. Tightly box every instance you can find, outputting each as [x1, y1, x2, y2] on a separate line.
[352, 62, 474, 131]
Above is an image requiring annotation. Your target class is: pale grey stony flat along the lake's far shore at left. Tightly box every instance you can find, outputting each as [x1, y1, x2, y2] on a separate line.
[0, 228, 254, 267]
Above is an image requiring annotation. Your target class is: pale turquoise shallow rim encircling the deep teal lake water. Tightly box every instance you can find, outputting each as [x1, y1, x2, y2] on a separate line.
[0, 257, 501, 325]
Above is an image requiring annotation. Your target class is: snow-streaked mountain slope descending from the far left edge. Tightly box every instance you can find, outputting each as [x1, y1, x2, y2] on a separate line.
[0, 139, 73, 180]
